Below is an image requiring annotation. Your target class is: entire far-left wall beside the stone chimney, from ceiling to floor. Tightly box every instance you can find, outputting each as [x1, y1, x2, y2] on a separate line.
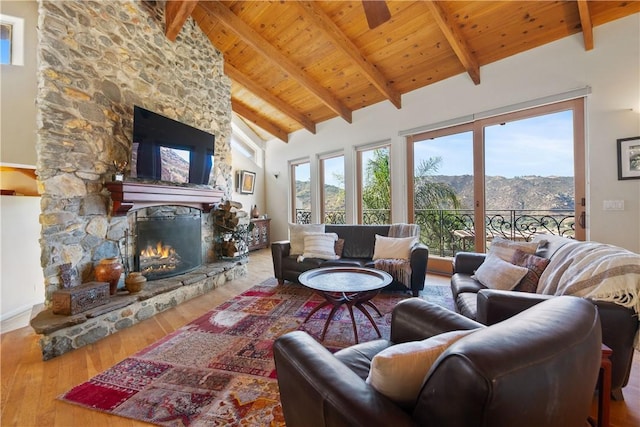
[0, 0, 44, 320]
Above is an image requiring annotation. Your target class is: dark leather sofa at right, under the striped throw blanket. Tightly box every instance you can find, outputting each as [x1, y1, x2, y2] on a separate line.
[451, 237, 638, 400]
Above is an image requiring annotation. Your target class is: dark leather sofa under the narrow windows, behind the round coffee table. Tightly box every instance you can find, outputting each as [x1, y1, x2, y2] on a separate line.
[271, 224, 429, 296]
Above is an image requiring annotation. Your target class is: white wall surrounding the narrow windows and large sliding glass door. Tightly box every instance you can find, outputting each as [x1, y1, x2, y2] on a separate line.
[265, 14, 640, 252]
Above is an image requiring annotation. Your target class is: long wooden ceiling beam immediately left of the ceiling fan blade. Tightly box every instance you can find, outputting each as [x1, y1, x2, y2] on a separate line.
[299, 1, 402, 108]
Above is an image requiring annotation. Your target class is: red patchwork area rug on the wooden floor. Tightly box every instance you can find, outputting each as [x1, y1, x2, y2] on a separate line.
[60, 279, 451, 426]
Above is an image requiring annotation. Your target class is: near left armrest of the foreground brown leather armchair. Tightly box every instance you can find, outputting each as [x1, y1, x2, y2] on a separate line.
[273, 331, 415, 427]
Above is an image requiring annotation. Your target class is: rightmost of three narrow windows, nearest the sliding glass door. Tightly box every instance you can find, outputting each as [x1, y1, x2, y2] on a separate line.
[357, 145, 392, 224]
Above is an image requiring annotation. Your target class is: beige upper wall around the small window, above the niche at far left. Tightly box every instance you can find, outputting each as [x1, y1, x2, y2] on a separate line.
[0, 0, 38, 166]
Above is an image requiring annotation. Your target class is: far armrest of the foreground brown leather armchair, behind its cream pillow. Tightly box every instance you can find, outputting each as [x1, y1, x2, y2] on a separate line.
[391, 298, 483, 343]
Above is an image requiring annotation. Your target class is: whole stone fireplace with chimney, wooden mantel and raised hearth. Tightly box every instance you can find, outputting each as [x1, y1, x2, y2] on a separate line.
[31, 0, 246, 360]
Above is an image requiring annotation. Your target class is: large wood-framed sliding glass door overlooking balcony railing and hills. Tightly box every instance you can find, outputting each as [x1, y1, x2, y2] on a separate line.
[408, 98, 586, 264]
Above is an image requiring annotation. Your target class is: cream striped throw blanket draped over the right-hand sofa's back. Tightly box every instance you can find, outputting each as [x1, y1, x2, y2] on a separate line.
[537, 242, 640, 348]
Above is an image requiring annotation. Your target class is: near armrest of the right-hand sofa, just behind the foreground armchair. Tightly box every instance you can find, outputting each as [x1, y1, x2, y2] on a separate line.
[476, 289, 553, 325]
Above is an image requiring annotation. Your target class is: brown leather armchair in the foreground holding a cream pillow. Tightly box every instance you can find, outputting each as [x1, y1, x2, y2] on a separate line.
[274, 296, 601, 427]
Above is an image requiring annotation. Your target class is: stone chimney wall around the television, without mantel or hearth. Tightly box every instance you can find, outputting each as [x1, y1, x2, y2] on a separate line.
[36, 0, 233, 305]
